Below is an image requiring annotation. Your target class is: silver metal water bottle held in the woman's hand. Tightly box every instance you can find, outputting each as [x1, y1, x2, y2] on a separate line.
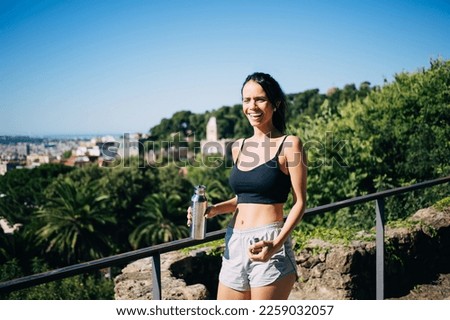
[191, 185, 208, 239]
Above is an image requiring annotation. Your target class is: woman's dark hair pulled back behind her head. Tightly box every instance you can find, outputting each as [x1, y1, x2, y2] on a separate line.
[241, 72, 287, 134]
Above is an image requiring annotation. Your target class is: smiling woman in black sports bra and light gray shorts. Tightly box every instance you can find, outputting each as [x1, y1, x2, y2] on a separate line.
[188, 73, 307, 300]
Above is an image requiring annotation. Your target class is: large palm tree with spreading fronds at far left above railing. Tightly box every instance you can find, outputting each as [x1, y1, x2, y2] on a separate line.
[36, 178, 116, 263]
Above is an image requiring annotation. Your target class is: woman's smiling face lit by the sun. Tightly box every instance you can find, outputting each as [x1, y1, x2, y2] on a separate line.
[242, 80, 274, 129]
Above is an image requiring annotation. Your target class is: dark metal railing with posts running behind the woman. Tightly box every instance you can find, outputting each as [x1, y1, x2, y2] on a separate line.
[0, 176, 450, 300]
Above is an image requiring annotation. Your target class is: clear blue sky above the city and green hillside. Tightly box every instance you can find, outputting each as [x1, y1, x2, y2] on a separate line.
[0, 0, 450, 135]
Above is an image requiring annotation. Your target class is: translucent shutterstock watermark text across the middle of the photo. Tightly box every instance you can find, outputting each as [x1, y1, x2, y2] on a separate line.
[100, 132, 349, 169]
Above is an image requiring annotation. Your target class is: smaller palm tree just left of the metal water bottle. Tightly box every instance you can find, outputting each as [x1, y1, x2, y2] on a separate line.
[129, 193, 189, 248]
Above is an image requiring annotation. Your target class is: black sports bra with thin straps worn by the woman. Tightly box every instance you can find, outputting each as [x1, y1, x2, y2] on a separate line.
[229, 136, 291, 204]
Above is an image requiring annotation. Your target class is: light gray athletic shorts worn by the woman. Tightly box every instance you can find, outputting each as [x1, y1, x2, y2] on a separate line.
[219, 222, 297, 291]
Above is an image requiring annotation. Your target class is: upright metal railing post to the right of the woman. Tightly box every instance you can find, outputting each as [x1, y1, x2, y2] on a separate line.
[375, 198, 384, 300]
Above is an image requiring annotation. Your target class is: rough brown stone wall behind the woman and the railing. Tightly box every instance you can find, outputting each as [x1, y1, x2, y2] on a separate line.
[115, 208, 450, 300]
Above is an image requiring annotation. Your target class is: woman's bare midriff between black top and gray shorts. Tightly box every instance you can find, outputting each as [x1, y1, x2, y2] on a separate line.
[230, 203, 283, 230]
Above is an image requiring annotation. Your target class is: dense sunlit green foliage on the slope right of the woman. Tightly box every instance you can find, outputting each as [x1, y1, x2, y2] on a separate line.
[291, 60, 450, 227]
